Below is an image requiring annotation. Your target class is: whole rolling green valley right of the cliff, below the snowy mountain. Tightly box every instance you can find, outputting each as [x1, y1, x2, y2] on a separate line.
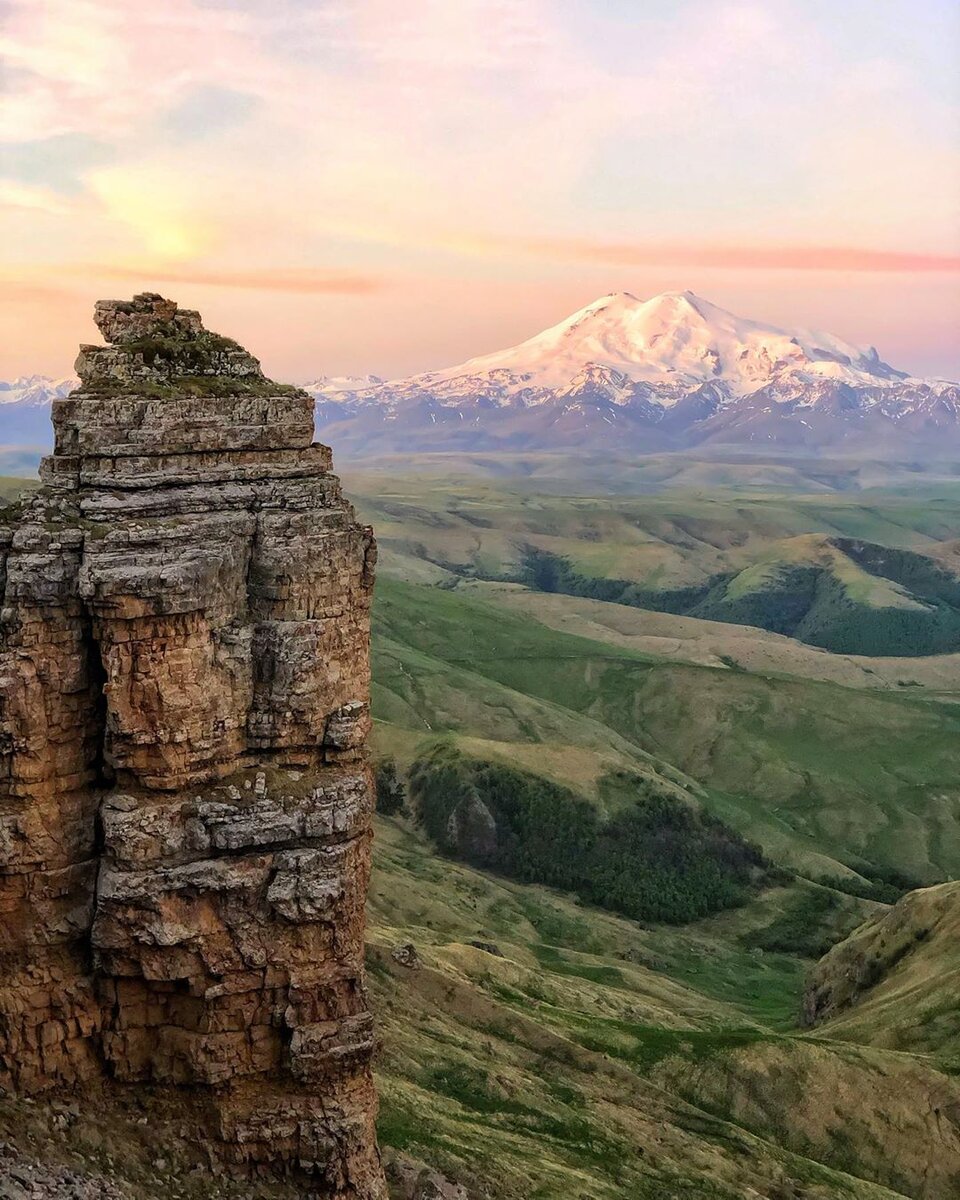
[348, 463, 960, 1200]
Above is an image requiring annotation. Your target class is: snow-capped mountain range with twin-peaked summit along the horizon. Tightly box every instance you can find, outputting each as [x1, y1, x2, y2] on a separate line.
[0, 292, 960, 457]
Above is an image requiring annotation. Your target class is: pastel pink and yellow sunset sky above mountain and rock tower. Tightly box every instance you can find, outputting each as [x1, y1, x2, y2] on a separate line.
[0, 0, 960, 380]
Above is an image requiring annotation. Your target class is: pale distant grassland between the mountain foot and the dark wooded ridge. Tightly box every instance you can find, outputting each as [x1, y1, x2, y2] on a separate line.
[347, 475, 960, 588]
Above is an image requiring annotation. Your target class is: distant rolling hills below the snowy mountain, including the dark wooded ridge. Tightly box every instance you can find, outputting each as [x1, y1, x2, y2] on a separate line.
[350, 475, 960, 655]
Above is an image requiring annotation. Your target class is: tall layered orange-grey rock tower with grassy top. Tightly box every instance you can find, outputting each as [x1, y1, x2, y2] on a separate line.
[0, 294, 384, 1200]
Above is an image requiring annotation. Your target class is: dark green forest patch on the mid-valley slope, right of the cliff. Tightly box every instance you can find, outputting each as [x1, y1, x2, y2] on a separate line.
[409, 744, 770, 924]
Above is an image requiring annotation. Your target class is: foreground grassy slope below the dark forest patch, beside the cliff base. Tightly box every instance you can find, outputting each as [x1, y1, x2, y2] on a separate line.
[368, 820, 960, 1200]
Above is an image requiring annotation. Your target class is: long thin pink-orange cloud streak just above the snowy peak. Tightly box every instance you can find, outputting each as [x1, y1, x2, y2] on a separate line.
[504, 238, 960, 272]
